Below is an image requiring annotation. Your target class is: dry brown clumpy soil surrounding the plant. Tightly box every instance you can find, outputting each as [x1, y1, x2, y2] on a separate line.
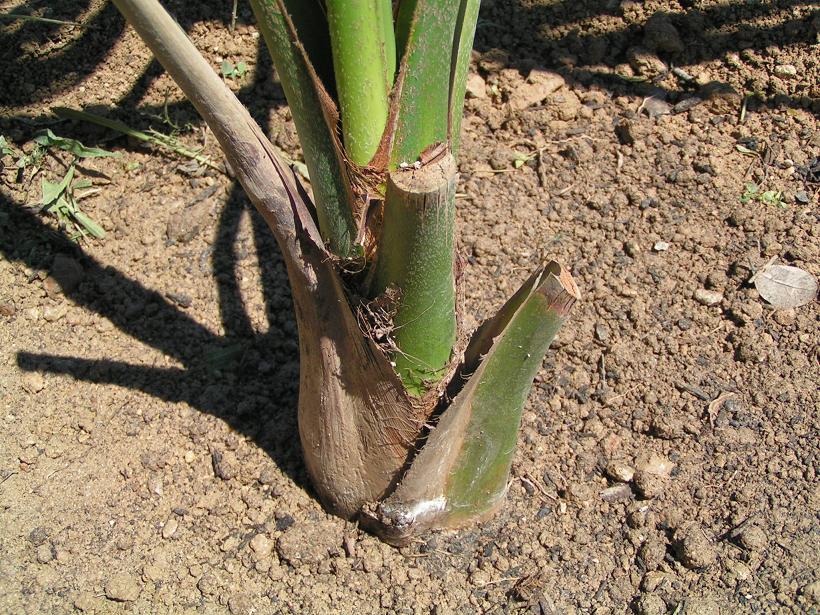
[0, 0, 820, 615]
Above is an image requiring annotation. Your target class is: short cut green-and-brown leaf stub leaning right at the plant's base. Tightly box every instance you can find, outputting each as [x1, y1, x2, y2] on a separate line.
[366, 262, 578, 544]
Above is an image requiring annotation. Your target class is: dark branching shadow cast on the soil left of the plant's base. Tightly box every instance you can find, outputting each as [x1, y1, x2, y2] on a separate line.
[7, 36, 308, 488]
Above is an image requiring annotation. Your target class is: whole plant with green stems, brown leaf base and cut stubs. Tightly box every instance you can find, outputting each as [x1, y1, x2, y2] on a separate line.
[114, 0, 578, 544]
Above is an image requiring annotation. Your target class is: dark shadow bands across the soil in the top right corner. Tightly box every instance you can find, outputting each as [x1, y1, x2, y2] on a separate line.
[475, 0, 819, 107]
